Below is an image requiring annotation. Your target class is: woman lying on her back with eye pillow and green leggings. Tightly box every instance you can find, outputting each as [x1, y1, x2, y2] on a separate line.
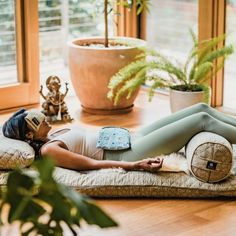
[3, 103, 236, 172]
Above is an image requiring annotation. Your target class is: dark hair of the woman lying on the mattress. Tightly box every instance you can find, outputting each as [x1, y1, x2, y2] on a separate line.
[2, 108, 45, 157]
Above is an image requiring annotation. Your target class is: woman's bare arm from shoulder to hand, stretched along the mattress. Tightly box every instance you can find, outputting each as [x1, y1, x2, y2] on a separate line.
[41, 142, 162, 172]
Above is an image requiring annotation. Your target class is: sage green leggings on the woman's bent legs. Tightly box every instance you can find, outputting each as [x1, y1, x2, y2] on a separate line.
[104, 103, 236, 161]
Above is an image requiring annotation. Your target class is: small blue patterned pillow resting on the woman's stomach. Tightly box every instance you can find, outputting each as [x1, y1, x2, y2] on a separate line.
[97, 126, 130, 150]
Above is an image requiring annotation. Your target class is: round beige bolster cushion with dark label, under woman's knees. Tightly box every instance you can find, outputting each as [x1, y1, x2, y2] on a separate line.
[185, 131, 233, 183]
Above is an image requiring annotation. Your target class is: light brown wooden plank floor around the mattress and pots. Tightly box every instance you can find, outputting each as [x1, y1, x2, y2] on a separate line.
[0, 91, 236, 236]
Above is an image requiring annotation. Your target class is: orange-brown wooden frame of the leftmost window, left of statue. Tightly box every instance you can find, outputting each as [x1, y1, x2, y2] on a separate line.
[0, 0, 39, 111]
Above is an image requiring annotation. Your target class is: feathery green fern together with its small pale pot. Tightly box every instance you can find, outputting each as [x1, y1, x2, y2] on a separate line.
[108, 30, 233, 112]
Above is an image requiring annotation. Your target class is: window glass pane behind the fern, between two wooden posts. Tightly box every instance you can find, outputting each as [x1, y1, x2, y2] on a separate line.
[146, 0, 198, 61]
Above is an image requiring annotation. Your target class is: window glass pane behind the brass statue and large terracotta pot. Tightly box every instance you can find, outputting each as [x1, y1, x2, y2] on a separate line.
[39, 0, 113, 96]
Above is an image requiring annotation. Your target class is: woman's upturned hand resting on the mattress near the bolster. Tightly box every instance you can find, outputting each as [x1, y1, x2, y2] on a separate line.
[134, 157, 163, 172]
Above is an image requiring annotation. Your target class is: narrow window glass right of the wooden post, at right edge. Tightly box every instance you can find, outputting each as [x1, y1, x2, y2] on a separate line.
[223, 0, 236, 109]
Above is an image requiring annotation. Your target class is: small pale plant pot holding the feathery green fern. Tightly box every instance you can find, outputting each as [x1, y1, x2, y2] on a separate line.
[170, 89, 204, 112]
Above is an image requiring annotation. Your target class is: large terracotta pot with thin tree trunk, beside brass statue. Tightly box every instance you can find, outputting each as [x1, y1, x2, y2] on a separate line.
[69, 37, 144, 114]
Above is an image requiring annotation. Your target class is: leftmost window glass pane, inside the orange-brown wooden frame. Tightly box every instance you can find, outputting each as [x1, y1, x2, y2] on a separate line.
[0, 0, 17, 86]
